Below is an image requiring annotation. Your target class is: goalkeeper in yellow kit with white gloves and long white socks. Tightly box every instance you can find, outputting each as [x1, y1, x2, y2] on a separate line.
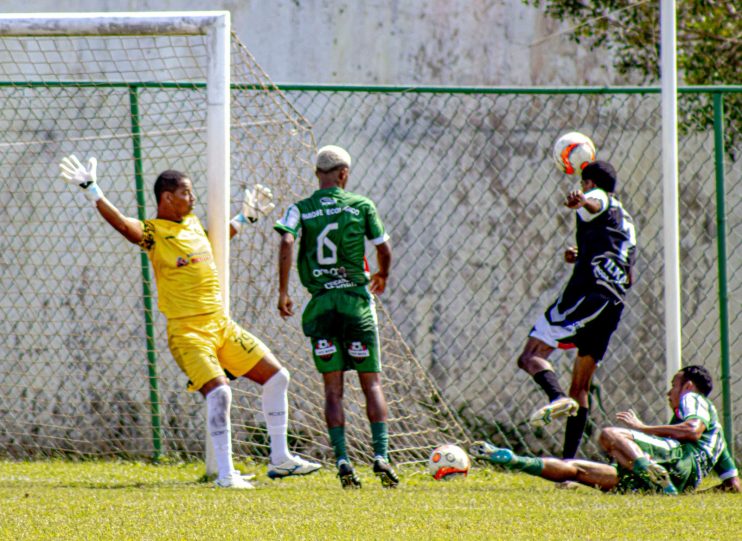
[60, 155, 320, 489]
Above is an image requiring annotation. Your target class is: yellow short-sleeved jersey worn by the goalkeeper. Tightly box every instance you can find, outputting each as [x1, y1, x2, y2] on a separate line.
[139, 214, 222, 319]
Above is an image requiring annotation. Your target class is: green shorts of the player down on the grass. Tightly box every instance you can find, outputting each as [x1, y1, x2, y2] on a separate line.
[616, 430, 708, 492]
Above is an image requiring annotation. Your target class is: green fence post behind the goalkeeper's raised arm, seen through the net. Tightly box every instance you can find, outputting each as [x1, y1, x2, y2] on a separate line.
[129, 85, 162, 461]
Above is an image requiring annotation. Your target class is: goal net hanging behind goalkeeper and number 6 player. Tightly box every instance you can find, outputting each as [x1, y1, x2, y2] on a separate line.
[0, 17, 465, 463]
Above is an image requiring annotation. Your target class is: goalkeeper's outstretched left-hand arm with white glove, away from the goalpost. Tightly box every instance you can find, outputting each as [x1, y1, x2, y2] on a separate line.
[59, 154, 144, 244]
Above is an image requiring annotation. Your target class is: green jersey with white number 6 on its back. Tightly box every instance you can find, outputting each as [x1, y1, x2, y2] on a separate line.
[274, 187, 389, 295]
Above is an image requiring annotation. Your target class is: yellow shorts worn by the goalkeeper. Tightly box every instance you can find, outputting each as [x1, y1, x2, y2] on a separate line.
[167, 313, 270, 391]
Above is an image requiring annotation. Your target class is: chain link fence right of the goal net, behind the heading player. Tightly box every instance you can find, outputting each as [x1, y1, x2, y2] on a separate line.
[284, 86, 742, 457]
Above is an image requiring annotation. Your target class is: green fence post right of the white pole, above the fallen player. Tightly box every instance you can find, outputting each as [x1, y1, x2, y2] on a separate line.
[713, 92, 734, 456]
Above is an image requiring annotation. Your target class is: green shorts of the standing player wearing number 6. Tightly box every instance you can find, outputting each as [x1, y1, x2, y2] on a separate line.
[301, 287, 381, 374]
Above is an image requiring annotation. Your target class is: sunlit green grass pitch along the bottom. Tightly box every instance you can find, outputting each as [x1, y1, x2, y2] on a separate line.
[0, 461, 742, 541]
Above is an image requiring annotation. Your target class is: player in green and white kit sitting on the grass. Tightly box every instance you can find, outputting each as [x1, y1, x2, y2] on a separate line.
[469, 365, 741, 495]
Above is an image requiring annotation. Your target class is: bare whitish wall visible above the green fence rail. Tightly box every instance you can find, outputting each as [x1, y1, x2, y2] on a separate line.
[5, 0, 624, 86]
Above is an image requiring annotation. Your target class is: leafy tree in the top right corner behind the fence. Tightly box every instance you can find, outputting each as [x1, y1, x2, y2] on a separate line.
[523, 0, 742, 157]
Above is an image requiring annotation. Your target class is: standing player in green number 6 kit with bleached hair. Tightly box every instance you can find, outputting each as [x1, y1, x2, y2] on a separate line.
[274, 145, 399, 488]
